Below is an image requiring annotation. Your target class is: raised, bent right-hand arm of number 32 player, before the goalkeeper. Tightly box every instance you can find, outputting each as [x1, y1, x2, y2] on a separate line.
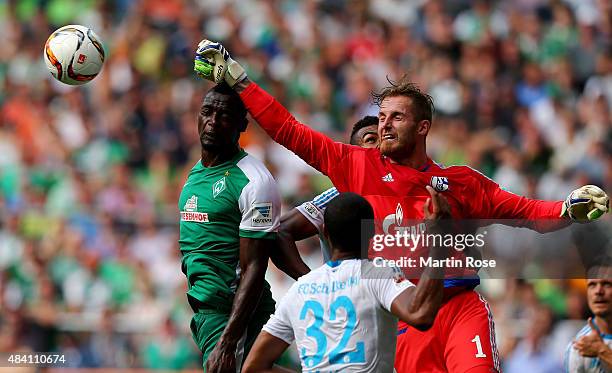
[391, 186, 450, 331]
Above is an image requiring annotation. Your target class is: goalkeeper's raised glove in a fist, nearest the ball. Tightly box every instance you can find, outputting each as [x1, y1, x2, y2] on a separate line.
[193, 39, 246, 87]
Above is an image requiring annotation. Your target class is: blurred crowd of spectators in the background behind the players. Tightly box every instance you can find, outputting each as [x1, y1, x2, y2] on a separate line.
[0, 0, 612, 373]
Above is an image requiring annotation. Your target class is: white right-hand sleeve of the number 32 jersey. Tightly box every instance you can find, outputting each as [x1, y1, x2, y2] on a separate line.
[363, 267, 415, 312]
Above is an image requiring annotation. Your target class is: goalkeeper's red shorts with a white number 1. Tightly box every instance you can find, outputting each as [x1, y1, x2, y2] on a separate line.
[395, 290, 501, 373]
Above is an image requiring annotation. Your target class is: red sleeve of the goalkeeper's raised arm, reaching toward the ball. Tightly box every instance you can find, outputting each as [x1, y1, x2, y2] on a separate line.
[240, 83, 360, 190]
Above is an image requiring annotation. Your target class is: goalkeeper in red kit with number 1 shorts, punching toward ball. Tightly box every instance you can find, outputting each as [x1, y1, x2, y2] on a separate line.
[195, 40, 609, 373]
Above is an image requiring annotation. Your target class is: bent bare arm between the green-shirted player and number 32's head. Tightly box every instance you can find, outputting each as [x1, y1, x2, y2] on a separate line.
[270, 208, 318, 280]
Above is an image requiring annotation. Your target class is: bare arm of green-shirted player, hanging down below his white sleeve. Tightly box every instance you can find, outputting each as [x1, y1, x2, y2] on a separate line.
[206, 238, 273, 373]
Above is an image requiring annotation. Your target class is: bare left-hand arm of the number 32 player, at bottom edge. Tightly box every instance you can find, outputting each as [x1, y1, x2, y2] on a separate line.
[242, 331, 293, 373]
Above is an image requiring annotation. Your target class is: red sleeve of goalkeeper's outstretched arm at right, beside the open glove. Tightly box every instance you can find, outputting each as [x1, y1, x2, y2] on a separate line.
[468, 168, 569, 232]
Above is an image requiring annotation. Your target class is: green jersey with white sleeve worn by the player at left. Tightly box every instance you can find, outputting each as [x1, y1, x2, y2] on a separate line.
[178, 150, 281, 310]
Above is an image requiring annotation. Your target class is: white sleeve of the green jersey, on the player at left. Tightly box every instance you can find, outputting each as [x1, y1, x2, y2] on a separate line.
[238, 160, 281, 239]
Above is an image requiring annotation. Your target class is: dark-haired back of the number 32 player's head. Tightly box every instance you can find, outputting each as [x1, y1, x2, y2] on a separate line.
[323, 192, 374, 257]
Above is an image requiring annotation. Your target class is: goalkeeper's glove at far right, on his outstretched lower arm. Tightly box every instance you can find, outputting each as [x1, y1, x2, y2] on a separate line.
[561, 185, 610, 223]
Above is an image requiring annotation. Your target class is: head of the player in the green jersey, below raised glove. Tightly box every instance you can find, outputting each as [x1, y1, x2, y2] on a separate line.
[198, 91, 246, 151]
